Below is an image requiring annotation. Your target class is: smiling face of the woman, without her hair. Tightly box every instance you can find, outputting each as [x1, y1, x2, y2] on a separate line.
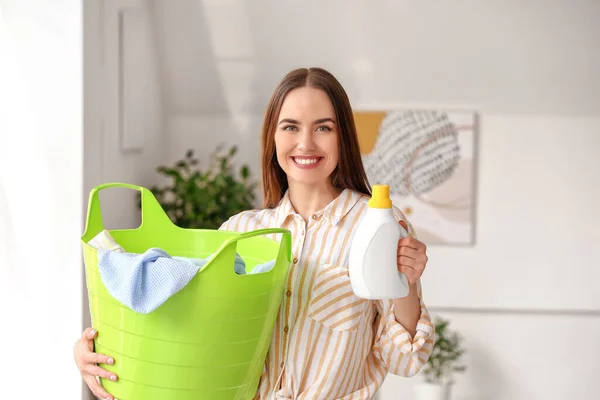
[275, 87, 339, 185]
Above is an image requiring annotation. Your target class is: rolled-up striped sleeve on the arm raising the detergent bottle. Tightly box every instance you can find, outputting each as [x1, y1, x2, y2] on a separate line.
[373, 283, 435, 377]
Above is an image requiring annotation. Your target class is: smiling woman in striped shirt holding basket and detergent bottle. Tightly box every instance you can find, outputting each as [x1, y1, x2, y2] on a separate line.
[75, 68, 434, 400]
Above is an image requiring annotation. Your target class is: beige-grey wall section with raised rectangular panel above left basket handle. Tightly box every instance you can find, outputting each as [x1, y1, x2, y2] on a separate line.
[82, 0, 165, 399]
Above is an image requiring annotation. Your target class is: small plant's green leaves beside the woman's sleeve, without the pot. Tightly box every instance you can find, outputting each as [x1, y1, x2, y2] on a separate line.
[423, 318, 467, 385]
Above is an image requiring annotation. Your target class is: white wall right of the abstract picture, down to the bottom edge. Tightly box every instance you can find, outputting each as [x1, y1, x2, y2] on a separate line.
[380, 114, 600, 400]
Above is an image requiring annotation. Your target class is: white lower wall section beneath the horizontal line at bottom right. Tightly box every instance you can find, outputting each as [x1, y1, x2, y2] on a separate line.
[379, 310, 600, 400]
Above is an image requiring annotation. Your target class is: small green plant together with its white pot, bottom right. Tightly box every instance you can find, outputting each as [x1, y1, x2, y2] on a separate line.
[415, 318, 466, 400]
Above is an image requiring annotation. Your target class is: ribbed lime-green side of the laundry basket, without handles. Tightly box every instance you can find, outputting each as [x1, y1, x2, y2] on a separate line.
[84, 233, 287, 400]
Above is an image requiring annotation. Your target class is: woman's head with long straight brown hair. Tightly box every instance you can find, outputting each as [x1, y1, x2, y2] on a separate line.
[262, 68, 371, 208]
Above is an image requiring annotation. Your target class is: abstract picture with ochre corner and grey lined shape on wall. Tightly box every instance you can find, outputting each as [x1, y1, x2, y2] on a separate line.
[354, 109, 476, 245]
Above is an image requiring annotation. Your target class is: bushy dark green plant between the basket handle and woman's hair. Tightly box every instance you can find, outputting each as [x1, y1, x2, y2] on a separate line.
[146, 146, 257, 229]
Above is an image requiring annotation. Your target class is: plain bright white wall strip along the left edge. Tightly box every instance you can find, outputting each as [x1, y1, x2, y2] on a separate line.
[0, 0, 83, 399]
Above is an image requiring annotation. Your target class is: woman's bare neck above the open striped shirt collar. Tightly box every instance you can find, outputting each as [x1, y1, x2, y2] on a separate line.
[289, 182, 342, 221]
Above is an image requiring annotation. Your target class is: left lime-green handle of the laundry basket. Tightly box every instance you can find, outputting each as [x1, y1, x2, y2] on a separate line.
[83, 182, 174, 237]
